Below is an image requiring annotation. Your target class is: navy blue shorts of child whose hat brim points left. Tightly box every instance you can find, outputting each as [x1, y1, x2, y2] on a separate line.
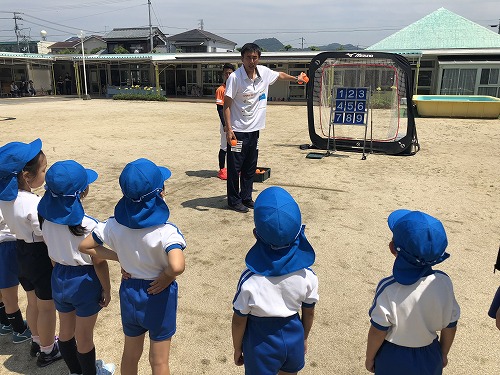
[375, 338, 443, 375]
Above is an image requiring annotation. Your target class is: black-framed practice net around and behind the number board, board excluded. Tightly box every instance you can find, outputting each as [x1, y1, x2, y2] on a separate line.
[306, 51, 419, 155]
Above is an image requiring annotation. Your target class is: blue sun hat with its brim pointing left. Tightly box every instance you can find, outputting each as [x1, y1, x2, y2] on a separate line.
[387, 210, 450, 285]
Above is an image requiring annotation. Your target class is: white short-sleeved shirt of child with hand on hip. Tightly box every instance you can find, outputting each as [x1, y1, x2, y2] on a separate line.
[92, 217, 186, 280]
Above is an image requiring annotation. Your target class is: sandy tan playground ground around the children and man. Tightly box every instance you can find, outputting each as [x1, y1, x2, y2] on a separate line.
[0, 97, 500, 375]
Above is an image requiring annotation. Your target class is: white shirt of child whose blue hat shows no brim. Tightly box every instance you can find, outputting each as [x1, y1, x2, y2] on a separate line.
[233, 268, 319, 318]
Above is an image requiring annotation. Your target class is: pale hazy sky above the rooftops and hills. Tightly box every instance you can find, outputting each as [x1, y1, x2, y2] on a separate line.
[0, 0, 500, 48]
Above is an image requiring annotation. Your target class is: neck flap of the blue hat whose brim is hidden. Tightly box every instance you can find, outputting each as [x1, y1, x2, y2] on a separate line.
[245, 226, 316, 276]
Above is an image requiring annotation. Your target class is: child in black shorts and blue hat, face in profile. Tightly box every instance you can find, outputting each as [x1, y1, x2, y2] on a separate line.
[0, 139, 61, 367]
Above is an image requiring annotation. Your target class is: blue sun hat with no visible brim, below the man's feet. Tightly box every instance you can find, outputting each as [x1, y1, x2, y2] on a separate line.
[245, 186, 315, 276]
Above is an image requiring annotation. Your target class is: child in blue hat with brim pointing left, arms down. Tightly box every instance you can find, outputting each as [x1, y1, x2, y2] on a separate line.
[365, 210, 460, 375]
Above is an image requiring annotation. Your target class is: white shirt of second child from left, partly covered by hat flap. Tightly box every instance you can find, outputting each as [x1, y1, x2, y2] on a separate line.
[42, 216, 98, 266]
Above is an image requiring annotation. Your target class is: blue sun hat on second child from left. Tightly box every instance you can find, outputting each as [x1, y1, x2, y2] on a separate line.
[38, 160, 97, 225]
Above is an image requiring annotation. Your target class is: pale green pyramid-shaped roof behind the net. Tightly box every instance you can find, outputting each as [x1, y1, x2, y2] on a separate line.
[367, 8, 500, 51]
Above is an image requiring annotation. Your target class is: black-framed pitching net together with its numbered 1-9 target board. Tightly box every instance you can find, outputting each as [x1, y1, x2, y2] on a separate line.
[308, 52, 418, 154]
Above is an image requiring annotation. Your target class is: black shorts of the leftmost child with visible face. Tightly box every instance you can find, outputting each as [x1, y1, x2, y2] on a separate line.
[16, 240, 53, 300]
